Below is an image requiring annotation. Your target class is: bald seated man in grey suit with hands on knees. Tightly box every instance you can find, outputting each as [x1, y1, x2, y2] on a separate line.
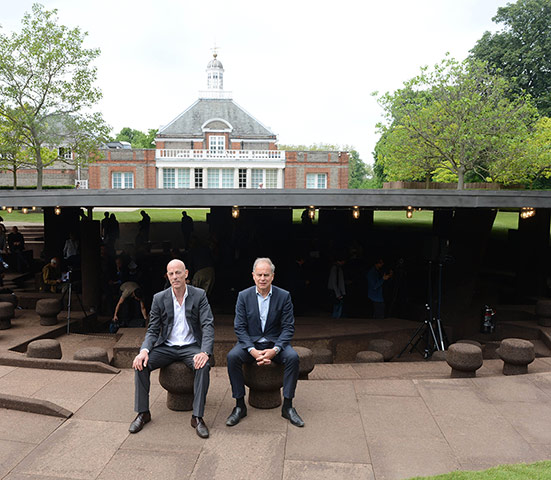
[129, 260, 214, 438]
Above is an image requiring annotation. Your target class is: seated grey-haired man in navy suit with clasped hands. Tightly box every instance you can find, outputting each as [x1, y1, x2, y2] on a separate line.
[226, 258, 304, 427]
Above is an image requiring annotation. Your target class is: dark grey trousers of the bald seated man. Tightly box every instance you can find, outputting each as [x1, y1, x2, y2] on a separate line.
[134, 343, 210, 417]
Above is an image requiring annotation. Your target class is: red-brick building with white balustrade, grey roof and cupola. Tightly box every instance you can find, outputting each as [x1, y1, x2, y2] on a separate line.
[0, 53, 349, 189]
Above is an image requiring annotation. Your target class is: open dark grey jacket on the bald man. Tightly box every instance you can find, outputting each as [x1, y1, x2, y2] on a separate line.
[141, 285, 214, 355]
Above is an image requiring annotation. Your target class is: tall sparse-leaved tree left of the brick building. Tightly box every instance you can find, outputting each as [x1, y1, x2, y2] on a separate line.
[0, 4, 107, 189]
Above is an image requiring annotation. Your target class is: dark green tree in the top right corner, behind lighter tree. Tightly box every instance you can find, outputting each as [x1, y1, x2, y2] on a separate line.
[471, 0, 551, 116]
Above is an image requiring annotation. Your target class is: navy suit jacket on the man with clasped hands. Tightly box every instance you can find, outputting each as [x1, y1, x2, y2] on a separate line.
[234, 285, 295, 350]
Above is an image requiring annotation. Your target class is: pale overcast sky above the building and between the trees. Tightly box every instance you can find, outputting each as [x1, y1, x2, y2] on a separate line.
[0, 0, 509, 163]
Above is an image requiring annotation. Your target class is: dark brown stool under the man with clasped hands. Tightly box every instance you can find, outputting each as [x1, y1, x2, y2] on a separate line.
[243, 362, 283, 408]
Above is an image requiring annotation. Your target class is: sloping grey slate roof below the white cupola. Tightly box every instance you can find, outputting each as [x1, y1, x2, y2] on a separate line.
[158, 98, 275, 138]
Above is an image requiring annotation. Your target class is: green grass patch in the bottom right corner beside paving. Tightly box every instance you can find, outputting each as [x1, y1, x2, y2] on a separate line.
[410, 461, 551, 480]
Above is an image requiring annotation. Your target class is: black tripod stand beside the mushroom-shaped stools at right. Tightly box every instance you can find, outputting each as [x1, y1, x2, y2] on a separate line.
[398, 260, 448, 359]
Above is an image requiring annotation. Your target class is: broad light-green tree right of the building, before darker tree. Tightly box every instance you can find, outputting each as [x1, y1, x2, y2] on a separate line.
[377, 57, 537, 189]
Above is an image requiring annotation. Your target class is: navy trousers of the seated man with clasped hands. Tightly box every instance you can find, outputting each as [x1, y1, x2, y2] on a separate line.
[227, 343, 299, 398]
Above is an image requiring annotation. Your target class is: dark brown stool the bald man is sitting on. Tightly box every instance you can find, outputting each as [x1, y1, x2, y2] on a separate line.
[159, 362, 195, 411]
